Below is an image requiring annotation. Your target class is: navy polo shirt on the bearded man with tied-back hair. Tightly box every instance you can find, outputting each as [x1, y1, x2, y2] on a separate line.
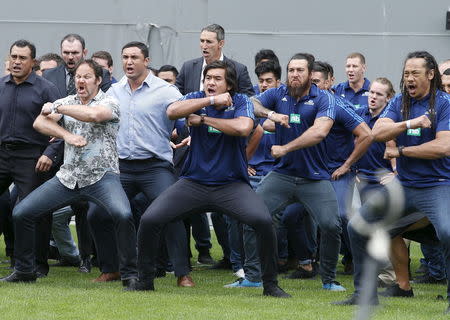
[256, 84, 336, 180]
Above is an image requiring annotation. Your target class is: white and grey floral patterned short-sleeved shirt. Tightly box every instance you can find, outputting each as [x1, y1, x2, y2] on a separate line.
[55, 90, 120, 189]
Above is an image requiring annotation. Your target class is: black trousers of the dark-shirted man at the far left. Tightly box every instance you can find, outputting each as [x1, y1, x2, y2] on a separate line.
[0, 145, 52, 274]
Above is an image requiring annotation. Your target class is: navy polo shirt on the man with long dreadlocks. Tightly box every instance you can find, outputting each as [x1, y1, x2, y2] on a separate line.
[380, 91, 450, 188]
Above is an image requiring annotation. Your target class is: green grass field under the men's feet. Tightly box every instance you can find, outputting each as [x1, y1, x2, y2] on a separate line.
[0, 234, 450, 320]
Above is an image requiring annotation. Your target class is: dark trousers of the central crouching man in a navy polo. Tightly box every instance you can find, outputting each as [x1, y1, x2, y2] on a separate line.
[138, 179, 278, 286]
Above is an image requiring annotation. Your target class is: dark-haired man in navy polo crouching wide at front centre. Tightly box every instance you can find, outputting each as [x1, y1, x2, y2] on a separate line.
[127, 61, 289, 297]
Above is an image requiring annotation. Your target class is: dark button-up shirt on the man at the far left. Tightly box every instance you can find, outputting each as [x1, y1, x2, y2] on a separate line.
[0, 72, 60, 146]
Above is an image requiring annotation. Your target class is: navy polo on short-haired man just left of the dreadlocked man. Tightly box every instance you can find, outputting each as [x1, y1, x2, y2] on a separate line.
[356, 107, 392, 183]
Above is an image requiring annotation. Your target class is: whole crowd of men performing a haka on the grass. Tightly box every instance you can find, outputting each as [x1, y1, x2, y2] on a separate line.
[0, 24, 450, 312]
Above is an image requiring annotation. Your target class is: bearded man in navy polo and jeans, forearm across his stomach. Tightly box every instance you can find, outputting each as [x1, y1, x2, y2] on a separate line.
[252, 53, 345, 291]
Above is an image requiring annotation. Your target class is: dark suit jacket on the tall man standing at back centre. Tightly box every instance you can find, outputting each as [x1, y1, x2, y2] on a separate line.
[175, 56, 255, 96]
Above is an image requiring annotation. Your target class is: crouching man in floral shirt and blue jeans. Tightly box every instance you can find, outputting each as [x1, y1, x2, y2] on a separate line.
[1, 60, 137, 285]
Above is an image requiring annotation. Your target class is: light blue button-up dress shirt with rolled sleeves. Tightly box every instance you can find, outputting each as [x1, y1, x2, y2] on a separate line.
[108, 72, 182, 162]
